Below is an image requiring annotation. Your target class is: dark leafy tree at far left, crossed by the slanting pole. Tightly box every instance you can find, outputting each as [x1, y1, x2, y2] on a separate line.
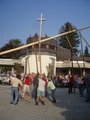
[0, 39, 23, 59]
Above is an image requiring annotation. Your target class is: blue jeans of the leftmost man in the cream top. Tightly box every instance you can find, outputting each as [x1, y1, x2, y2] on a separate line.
[10, 87, 19, 104]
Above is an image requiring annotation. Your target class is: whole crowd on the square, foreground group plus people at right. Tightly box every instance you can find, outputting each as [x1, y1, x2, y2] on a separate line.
[10, 73, 90, 105]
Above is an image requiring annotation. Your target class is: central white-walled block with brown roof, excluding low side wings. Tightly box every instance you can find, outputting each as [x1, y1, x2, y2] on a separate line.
[21, 34, 70, 75]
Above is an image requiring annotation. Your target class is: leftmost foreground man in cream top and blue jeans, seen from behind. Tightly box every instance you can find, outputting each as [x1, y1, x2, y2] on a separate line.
[10, 74, 22, 105]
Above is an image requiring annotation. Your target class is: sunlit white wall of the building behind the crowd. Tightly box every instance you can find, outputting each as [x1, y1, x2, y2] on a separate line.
[21, 54, 56, 75]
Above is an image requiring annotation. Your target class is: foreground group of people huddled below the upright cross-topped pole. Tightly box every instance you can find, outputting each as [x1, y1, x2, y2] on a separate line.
[10, 73, 56, 105]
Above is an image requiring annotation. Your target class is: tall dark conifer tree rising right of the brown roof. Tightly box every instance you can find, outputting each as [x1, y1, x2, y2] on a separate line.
[58, 22, 80, 53]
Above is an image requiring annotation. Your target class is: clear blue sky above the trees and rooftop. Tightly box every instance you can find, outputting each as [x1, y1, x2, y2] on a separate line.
[0, 0, 90, 47]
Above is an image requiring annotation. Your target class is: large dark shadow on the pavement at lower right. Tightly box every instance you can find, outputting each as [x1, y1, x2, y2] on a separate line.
[54, 88, 90, 120]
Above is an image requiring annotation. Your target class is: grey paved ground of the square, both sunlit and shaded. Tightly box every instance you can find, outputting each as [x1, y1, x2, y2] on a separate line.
[0, 85, 90, 120]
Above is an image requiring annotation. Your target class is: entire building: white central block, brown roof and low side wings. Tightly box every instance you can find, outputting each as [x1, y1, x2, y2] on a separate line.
[0, 34, 90, 75]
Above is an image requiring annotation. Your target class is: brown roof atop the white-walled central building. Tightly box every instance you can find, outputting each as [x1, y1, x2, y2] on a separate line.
[21, 34, 70, 60]
